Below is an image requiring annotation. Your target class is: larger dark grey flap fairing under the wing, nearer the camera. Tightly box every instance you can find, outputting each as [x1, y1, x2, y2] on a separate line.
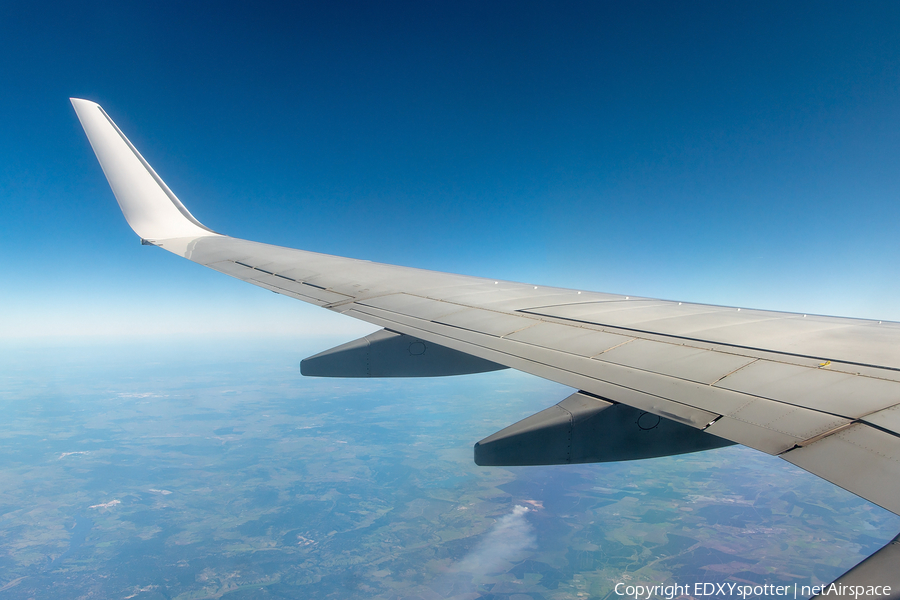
[475, 392, 734, 466]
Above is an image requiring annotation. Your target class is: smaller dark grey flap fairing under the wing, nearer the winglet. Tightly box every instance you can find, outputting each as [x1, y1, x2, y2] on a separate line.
[300, 329, 507, 377]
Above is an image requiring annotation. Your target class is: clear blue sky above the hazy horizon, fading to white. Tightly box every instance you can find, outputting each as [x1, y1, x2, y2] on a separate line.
[0, 1, 900, 339]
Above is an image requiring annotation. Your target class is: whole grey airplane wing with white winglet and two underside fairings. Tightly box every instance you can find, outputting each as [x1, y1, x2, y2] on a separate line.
[72, 99, 900, 591]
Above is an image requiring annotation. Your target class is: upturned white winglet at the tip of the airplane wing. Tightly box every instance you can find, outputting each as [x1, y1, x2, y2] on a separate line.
[70, 98, 217, 241]
